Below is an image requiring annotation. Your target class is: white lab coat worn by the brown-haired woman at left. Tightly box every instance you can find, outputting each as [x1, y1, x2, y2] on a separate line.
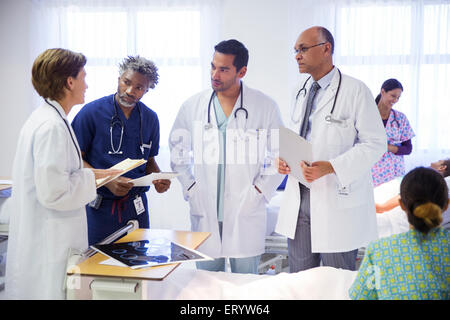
[5, 101, 96, 299]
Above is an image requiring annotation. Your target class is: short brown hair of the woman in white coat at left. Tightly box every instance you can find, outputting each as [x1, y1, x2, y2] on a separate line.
[31, 48, 86, 100]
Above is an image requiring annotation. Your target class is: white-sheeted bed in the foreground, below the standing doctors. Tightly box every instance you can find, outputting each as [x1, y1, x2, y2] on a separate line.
[147, 267, 357, 300]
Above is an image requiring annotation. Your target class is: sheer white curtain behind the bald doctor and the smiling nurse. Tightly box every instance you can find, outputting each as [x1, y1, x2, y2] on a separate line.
[289, 0, 450, 170]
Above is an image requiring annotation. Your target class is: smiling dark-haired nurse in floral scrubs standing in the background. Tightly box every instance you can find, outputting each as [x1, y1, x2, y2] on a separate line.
[372, 79, 415, 187]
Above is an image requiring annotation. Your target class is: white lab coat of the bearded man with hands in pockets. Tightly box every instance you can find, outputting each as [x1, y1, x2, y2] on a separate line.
[169, 84, 283, 258]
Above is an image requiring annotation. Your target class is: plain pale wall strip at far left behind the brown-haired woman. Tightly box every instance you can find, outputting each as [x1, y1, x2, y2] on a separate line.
[0, 0, 37, 177]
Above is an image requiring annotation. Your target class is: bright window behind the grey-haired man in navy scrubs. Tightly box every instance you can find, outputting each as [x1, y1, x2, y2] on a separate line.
[64, 7, 208, 146]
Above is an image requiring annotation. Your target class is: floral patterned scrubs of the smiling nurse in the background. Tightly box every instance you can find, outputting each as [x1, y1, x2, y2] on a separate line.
[372, 109, 415, 187]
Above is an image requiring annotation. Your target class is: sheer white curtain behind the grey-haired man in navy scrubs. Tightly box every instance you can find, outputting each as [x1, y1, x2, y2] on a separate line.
[28, 0, 221, 149]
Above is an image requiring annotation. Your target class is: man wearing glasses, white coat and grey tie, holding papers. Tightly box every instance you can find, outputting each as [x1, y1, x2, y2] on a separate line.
[275, 27, 387, 272]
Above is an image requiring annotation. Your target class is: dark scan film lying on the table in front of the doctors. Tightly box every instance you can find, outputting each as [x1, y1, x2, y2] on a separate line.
[91, 237, 212, 269]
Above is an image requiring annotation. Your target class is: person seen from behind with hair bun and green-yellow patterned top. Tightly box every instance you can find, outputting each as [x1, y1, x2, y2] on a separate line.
[349, 167, 450, 300]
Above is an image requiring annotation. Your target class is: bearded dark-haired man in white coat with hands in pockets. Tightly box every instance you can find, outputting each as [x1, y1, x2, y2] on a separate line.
[169, 40, 283, 273]
